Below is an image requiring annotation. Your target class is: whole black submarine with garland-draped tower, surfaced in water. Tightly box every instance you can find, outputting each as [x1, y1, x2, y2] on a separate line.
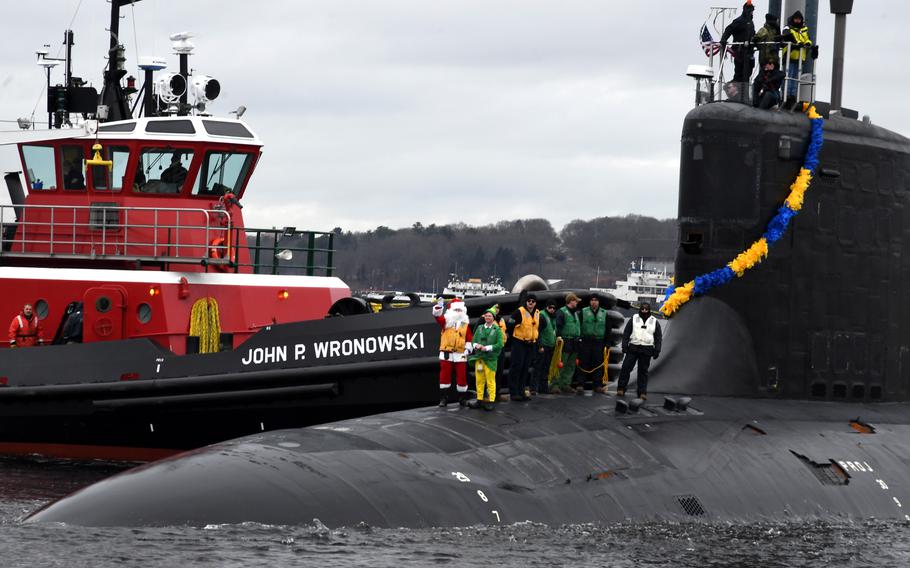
[26, 0, 910, 527]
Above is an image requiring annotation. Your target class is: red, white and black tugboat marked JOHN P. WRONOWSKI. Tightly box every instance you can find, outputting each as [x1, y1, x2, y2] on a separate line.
[0, 0, 528, 460]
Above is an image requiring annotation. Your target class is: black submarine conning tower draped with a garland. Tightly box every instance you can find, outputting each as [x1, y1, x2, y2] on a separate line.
[655, 102, 910, 401]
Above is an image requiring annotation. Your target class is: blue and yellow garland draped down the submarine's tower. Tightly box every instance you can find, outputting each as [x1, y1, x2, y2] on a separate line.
[660, 104, 823, 317]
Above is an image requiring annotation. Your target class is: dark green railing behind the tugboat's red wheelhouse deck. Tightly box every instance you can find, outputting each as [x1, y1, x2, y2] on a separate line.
[231, 227, 335, 276]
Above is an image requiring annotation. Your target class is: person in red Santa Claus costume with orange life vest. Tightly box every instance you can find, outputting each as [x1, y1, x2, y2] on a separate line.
[433, 298, 472, 407]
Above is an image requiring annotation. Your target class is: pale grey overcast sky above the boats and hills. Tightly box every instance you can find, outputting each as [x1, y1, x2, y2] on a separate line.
[0, 0, 910, 230]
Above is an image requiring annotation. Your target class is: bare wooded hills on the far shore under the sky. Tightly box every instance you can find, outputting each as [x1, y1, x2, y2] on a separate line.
[333, 215, 677, 293]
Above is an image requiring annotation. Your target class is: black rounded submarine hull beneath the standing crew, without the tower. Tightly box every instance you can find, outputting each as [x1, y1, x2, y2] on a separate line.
[28, 395, 910, 527]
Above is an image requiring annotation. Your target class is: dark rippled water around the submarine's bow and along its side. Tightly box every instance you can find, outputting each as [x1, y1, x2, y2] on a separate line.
[0, 460, 910, 568]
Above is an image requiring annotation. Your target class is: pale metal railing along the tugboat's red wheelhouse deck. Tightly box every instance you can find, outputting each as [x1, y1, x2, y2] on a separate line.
[0, 204, 233, 264]
